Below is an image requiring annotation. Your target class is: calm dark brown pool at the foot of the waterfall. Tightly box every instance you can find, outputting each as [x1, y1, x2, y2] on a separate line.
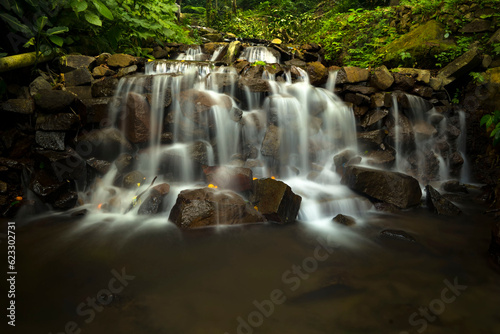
[2, 192, 500, 334]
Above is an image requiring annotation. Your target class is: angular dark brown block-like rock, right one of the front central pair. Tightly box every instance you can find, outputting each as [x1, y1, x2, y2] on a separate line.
[252, 179, 302, 224]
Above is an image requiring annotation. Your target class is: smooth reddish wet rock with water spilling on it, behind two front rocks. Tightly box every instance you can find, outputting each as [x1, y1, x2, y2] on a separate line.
[203, 166, 253, 192]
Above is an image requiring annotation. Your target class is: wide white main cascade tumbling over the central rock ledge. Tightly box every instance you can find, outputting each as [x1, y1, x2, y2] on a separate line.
[80, 56, 371, 226]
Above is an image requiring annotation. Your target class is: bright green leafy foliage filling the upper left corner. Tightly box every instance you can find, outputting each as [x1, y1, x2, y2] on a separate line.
[0, 0, 192, 55]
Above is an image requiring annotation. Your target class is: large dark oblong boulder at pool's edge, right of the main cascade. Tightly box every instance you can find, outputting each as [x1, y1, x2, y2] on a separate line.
[342, 166, 422, 209]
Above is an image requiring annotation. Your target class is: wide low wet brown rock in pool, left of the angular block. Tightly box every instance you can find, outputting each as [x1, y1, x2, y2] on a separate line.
[169, 188, 266, 230]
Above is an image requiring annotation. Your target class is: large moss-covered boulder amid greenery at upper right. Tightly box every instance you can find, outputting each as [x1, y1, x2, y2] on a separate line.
[379, 20, 456, 67]
